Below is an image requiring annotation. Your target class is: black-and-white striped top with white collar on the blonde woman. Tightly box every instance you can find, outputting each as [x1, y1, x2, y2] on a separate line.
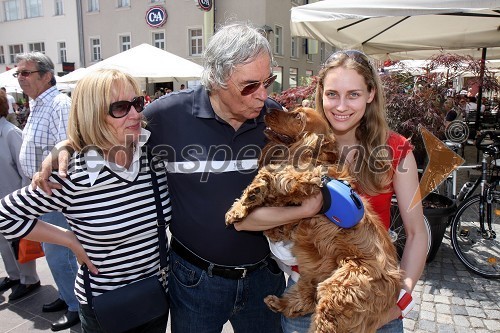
[0, 131, 171, 304]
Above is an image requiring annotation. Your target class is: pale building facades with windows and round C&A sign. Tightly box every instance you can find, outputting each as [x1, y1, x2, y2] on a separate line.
[0, 0, 333, 93]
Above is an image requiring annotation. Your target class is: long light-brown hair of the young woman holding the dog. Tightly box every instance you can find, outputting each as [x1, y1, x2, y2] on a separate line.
[316, 50, 394, 195]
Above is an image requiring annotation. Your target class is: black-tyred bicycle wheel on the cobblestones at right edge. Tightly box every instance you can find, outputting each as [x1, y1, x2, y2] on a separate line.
[450, 195, 500, 278]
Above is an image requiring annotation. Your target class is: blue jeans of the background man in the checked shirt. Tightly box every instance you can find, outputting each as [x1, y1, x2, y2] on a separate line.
[40, 212, 79, 312]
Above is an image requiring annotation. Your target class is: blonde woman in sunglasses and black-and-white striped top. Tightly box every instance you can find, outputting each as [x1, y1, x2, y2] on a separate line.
[0, 70, 170, 333]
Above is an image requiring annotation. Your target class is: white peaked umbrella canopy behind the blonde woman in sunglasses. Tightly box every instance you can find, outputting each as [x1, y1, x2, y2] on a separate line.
[61, 44, 203, 82]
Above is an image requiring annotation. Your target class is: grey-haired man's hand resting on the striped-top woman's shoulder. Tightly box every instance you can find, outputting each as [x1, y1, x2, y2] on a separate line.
[31, 140, 73, 195]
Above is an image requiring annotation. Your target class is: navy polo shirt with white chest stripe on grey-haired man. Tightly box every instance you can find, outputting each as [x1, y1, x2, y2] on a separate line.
[144, 86, 281, 266]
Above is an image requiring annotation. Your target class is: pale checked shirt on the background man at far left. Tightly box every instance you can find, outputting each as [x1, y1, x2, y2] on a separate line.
[19, 86, 71, 178]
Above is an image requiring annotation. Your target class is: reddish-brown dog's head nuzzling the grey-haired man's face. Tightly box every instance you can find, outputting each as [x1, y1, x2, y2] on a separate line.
[264, 107, 331, 145]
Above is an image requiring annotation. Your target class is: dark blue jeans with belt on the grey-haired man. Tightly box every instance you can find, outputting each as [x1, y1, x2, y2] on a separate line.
[168, 250, 285, 333]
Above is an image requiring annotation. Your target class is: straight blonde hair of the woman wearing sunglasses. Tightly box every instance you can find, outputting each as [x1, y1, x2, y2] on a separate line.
[68, 69, 141, 151]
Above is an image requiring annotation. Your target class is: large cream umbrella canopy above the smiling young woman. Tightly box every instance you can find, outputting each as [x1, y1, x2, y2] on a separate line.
[291, 0, 500, 54]
